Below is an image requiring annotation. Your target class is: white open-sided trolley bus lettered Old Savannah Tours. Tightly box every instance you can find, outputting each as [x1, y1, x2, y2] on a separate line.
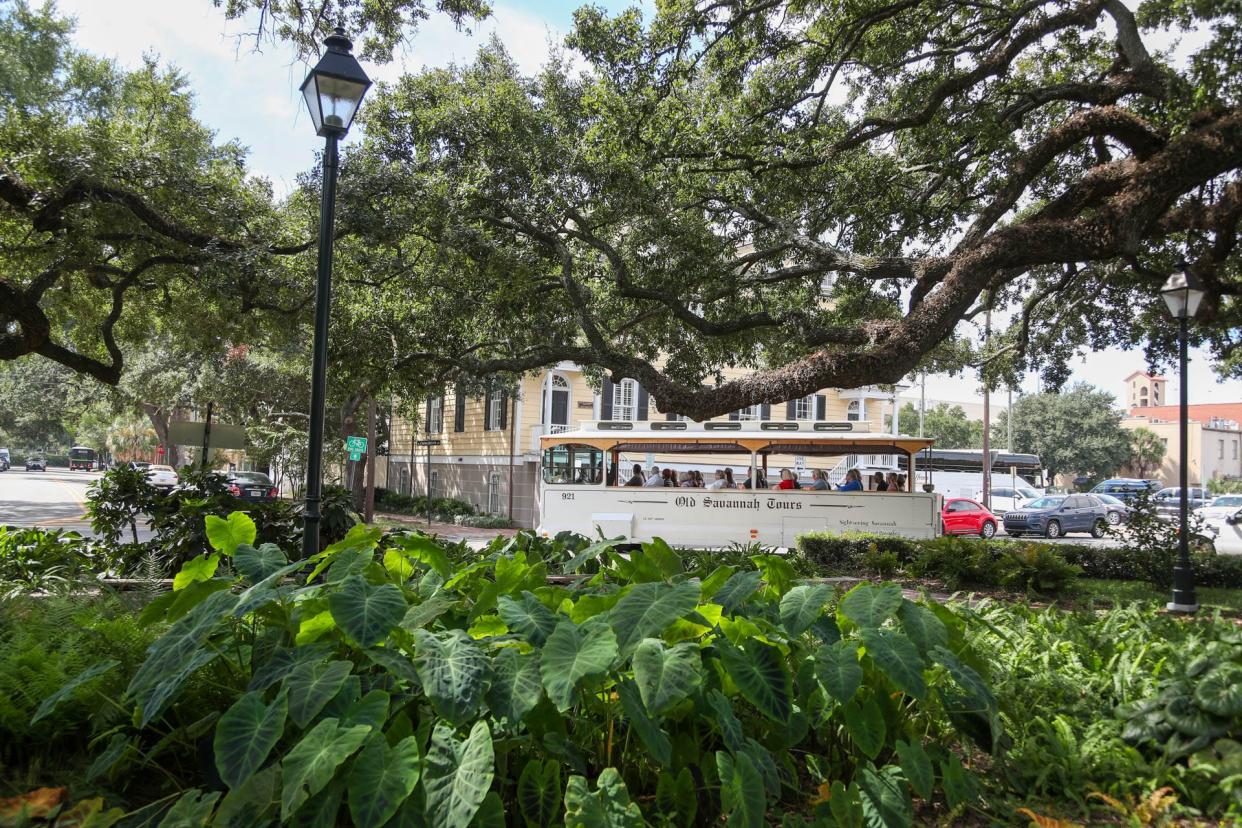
[537, 421, 943, 547]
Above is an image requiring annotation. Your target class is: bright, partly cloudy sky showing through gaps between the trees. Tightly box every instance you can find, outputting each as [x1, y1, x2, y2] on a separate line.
[57, 0, 1242, 412]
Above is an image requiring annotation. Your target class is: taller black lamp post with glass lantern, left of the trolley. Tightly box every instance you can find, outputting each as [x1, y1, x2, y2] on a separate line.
[302, 29, 371, 557]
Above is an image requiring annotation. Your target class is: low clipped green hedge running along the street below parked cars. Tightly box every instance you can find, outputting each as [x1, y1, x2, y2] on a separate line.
[797, 533, 1242, 591]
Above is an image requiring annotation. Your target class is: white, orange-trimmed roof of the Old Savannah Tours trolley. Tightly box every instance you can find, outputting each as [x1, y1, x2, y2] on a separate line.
[539, 420, 935, 454]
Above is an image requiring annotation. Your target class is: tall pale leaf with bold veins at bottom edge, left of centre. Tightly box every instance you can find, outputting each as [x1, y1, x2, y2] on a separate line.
[424, 721, 496, 828]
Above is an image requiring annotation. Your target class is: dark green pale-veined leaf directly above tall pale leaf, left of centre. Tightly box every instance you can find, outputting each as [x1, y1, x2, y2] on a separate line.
[414, 629, 488, 725]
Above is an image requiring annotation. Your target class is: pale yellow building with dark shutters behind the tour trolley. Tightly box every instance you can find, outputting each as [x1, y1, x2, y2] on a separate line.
[375, 362, 899, 526]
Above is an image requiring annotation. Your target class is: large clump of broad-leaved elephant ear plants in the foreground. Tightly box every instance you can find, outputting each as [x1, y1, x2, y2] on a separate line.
[40, 514, 1001, 828]
